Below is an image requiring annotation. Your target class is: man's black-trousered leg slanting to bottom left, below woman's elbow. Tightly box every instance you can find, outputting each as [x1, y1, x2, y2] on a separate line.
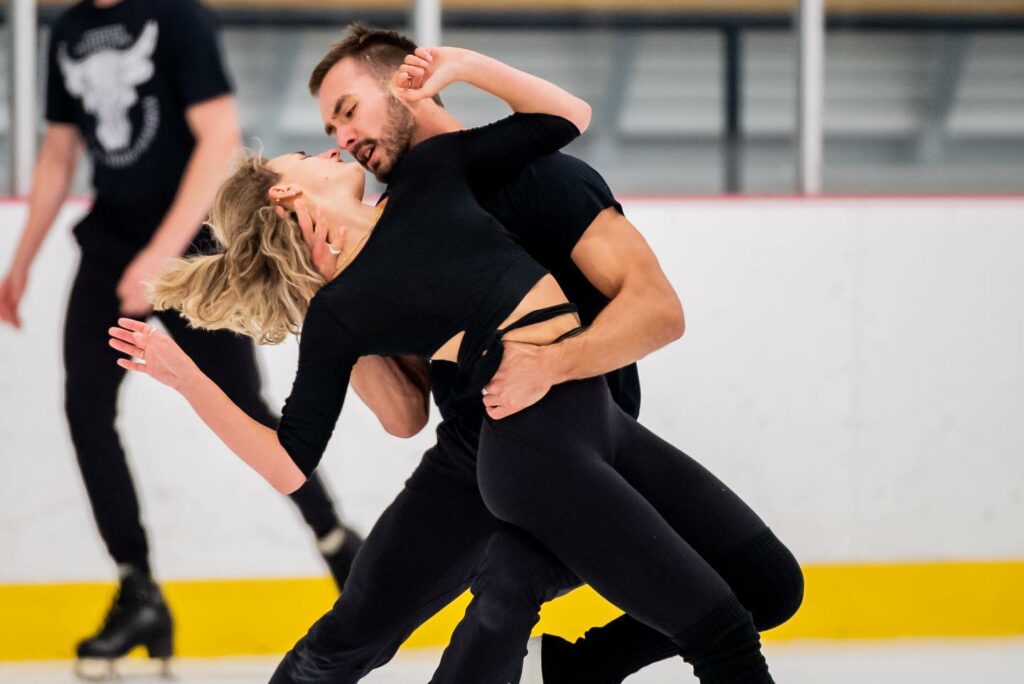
[271, 446, 499, 684]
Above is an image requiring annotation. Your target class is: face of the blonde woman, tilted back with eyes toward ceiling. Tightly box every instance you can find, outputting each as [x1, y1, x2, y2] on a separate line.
[266, 149, 367, 206]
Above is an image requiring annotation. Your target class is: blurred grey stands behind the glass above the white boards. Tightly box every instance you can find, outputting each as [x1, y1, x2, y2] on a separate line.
[0, 0, 1024, 195]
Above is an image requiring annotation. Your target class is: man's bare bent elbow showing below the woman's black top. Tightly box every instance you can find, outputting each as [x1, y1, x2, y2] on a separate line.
[349, 356, 430, 437]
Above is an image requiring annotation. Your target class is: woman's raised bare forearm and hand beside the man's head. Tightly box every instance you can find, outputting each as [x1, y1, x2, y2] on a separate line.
[394, 47, 591, 133]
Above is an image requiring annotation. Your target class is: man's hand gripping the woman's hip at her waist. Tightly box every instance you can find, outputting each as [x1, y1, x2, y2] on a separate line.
[483, 342, 562, 420]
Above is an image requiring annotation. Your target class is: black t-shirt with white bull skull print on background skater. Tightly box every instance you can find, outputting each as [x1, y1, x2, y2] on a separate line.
[46, 0, 231, 213]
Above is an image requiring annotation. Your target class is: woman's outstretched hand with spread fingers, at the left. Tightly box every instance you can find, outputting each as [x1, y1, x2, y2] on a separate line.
[109, 318, 202, 391]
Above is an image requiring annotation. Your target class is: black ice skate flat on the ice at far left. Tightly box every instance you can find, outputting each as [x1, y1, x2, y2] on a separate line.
[75, 569, 174, 680]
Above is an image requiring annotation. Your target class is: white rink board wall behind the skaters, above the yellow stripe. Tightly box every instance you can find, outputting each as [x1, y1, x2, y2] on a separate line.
[0, 200, 1024, 583]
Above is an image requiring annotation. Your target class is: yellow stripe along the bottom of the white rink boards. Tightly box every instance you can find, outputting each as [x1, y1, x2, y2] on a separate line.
[0, 561, 1024, 660]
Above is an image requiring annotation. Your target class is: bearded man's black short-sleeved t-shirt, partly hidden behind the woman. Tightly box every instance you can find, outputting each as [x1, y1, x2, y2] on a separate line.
[430, 153, 640, 443]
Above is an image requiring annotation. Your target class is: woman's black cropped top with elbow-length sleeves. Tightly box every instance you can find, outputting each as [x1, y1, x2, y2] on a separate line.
[278, 114, 580, 475]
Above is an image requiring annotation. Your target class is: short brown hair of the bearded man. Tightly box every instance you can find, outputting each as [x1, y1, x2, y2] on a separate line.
[309, 22, 441, 104]
